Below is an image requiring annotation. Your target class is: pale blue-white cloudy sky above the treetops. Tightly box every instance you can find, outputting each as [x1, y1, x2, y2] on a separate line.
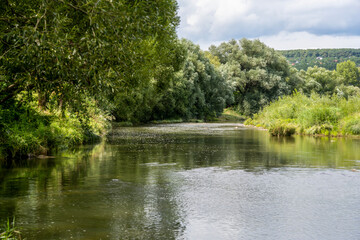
[178, 0, 360, 50]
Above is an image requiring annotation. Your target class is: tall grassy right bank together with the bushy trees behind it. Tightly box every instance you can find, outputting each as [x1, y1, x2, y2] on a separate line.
[246, 61, 360, 136]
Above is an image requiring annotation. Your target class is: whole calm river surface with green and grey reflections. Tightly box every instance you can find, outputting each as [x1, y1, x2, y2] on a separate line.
[0, 124, 360, 240]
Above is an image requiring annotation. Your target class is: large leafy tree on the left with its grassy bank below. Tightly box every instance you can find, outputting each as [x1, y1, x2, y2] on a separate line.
[0, 0, 182, 160]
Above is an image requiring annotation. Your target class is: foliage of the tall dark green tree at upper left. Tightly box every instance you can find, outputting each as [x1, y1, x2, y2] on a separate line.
[0, 0, 179, 113]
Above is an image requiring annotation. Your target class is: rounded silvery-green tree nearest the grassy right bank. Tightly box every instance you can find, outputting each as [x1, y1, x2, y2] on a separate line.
[209, 39, 299, 116]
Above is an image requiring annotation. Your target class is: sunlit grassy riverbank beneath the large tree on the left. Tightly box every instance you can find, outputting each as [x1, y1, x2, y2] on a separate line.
[0, 101, 109, 160]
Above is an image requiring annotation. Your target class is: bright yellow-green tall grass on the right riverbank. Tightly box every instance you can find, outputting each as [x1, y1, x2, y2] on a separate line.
[245, 93, 360, 136]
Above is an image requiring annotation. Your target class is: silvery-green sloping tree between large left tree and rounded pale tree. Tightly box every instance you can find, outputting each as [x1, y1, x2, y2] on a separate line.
[153, 40, 233, 120]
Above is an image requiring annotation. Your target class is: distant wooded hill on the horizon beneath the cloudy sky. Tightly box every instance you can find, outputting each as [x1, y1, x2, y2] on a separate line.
[279, 48, 360, 70]
